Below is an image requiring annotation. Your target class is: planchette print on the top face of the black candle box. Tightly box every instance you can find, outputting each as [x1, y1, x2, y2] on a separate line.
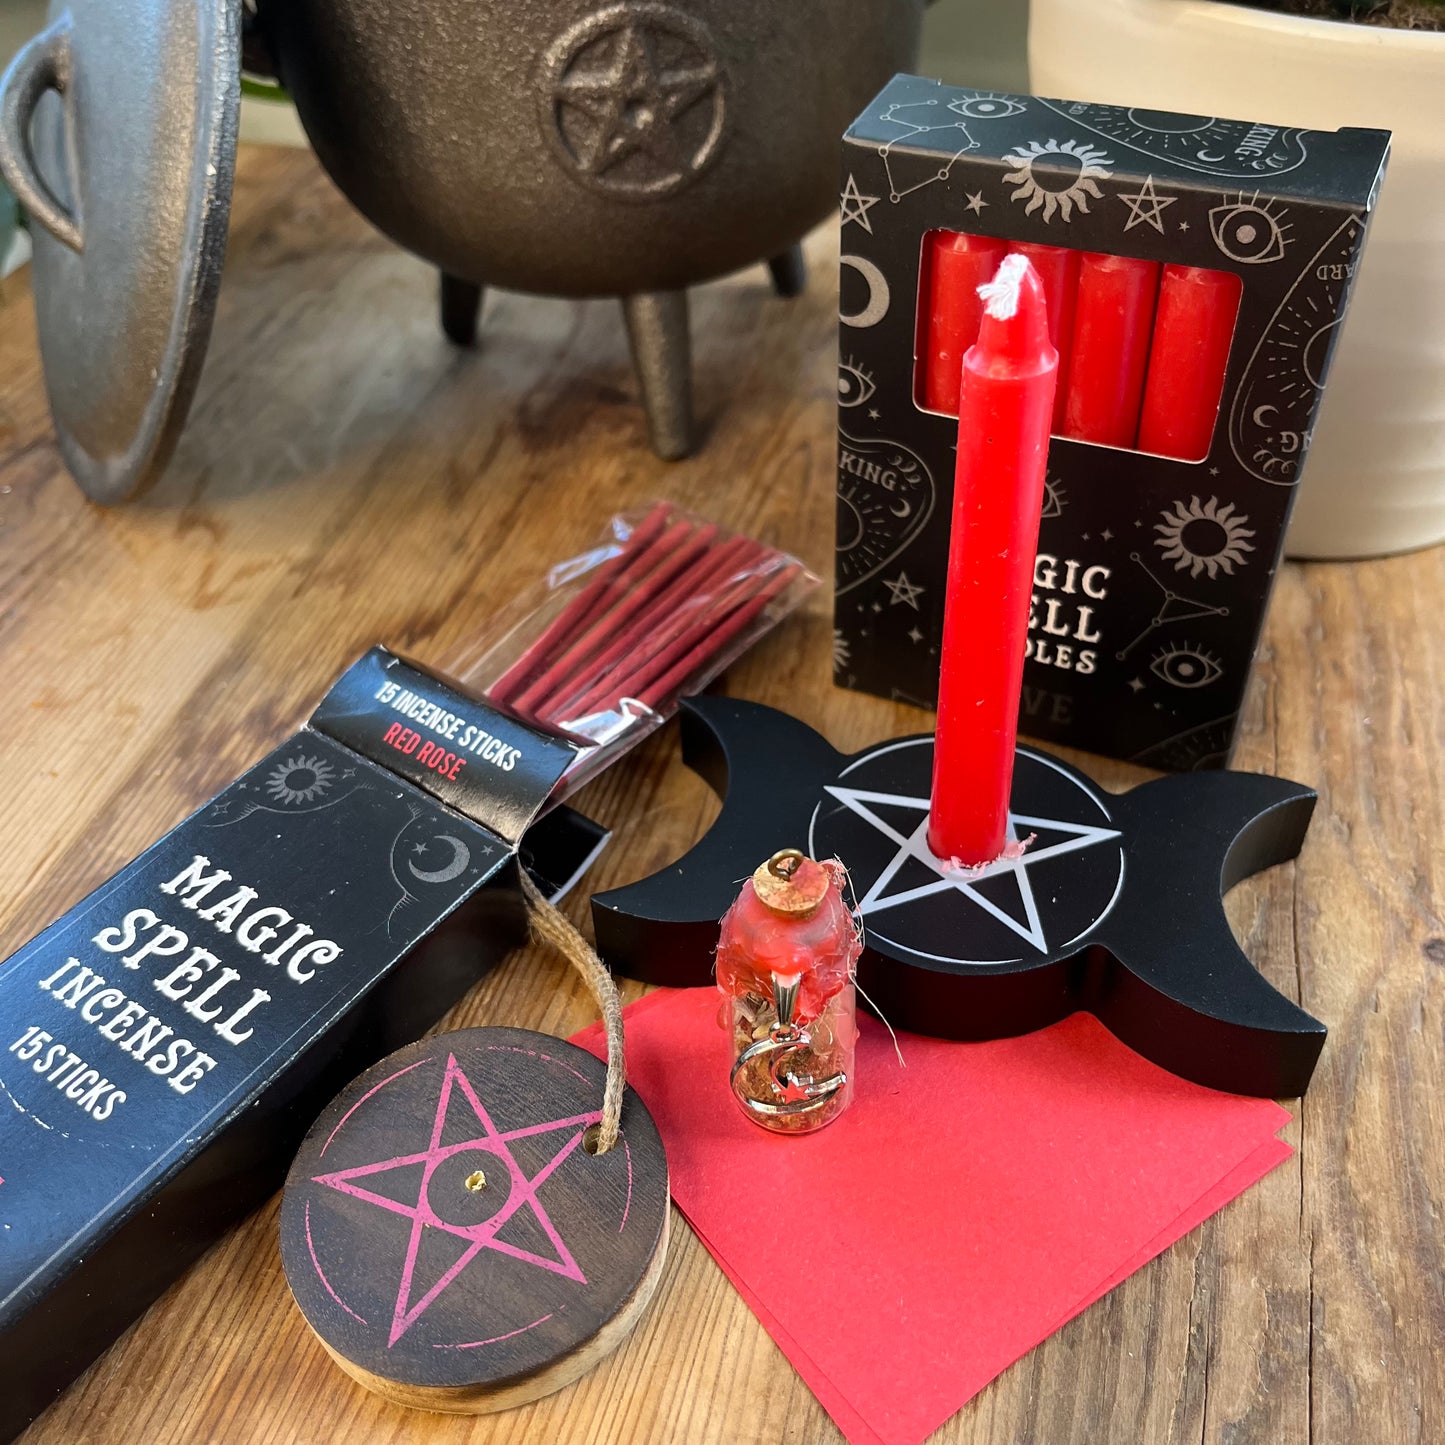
[1039, 100, 1308, 181]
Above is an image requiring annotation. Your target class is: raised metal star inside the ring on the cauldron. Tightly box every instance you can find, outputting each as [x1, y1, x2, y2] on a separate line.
[556, 25, 718, 175]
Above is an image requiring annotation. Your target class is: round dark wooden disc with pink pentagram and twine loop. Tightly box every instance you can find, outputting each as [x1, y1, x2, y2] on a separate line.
[280, 1028, 668, 1413]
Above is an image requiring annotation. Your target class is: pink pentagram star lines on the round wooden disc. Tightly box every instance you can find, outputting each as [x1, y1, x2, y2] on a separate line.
[312, 1053, 603, 1348]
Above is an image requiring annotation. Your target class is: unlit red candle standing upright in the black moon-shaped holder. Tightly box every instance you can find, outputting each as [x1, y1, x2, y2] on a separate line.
[928, 254, 1059, 867]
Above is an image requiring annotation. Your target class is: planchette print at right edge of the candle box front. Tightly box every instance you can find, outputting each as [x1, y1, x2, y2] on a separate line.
[1230, 215, 1361, 487]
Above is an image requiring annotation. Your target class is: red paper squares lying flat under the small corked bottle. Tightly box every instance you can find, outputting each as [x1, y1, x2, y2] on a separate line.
[577, 988, 1290, 1445]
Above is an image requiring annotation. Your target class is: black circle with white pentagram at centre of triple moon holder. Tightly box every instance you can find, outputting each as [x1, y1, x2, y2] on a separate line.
[809, 738, 1124, 965]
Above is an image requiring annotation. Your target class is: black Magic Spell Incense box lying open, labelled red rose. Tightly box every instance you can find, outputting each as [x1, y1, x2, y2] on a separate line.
[0, 649, 607, 1439]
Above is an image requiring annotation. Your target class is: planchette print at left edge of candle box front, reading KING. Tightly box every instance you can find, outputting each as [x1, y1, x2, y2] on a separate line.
[837, 431, 935, 597]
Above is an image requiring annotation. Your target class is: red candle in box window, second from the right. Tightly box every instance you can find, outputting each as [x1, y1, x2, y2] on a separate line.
[1064, 251, 1159, 447]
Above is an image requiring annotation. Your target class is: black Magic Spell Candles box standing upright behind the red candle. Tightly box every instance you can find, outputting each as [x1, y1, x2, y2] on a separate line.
[834, 75, 1390, 770]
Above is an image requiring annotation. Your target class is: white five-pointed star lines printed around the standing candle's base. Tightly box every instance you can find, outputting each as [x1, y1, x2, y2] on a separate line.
[824, 785, 1120, 954]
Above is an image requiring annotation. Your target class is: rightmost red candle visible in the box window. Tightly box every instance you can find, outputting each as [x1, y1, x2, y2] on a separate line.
[1139, 266, 1243, 461]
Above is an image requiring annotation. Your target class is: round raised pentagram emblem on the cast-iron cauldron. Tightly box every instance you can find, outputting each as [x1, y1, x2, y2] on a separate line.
[538, 3, 728, 201]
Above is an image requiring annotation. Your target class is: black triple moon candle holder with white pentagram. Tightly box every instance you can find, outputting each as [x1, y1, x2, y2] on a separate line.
[592, 698, 1325, 1098]
